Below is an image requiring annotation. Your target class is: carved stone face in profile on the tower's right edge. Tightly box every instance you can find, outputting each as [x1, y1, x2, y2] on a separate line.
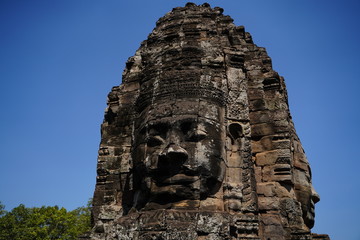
[294, 166, 320, 228]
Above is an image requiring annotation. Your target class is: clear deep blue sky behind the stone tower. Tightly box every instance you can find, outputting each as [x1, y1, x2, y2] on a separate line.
[0, 0, 360, 240]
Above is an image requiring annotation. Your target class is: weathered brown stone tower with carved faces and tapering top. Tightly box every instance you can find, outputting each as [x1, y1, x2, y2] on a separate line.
[91, 3, 329, 240]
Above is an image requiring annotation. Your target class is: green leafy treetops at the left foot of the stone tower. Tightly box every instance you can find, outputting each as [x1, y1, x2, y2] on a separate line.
[0, 202, 91, 240]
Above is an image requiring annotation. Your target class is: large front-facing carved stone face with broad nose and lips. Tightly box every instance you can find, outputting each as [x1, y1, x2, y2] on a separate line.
[133, 101, 225, 208]
